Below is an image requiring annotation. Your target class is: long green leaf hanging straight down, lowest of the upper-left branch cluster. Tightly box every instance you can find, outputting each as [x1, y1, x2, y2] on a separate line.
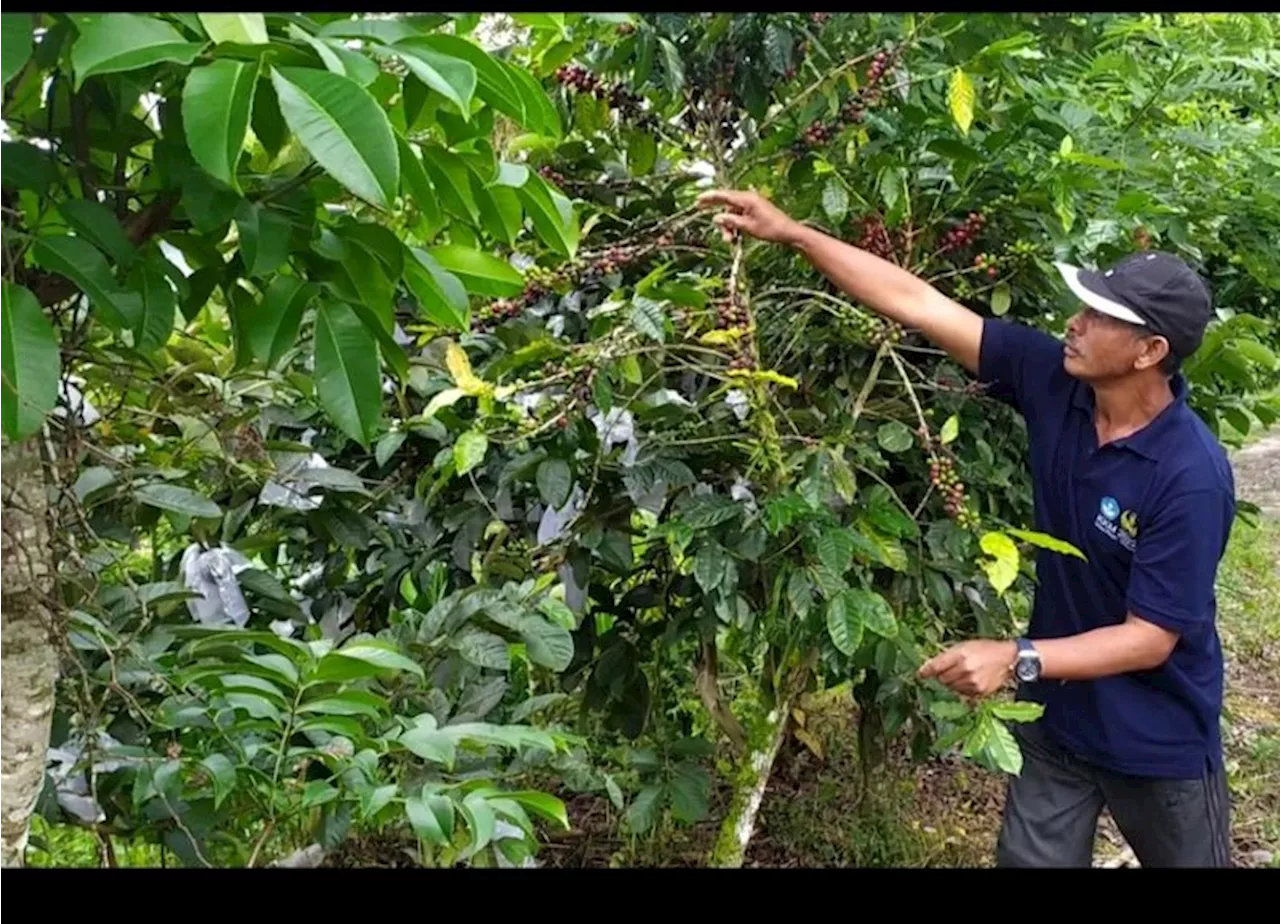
[315, 299, 381, 449]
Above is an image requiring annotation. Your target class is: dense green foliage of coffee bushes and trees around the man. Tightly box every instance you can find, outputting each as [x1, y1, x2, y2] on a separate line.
[0, 13, 1280, 865]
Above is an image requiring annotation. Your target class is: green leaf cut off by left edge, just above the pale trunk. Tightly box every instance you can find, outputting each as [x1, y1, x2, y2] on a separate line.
[0, 280, 59, 443]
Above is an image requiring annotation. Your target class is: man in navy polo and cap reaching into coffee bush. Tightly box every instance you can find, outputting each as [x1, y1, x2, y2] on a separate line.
[699, 191, 1235, 866]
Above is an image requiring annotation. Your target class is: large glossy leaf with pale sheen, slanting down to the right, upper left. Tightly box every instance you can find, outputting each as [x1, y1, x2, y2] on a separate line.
[271, 68, 399, 210]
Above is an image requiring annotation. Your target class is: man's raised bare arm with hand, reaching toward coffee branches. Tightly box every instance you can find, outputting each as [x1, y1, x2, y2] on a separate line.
[698, 189, 982, 374]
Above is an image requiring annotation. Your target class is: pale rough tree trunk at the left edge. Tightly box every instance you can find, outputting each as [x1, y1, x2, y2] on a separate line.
[0, 438, 58, 868]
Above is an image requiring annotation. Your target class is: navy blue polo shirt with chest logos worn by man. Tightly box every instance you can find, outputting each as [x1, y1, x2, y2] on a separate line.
[978, 319, 1235, 779]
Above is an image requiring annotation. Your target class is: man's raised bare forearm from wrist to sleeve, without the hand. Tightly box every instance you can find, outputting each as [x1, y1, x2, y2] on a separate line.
[787, 224, 982, 372]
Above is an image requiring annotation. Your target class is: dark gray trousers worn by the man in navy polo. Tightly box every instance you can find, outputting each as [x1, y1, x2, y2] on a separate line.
[996, 723, 1231, 866]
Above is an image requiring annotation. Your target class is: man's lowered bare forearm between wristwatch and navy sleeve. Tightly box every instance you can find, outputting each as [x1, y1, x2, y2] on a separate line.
[1032, 622, 1172, 680]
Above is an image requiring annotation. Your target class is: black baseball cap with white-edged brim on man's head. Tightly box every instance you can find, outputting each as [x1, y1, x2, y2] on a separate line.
[1055, 251, 1213, 360]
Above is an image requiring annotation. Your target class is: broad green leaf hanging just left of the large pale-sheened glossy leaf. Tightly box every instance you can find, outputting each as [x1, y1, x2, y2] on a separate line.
[182, 58, 259, 191]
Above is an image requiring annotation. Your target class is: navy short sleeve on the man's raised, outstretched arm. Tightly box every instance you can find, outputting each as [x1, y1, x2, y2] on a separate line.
[978, 317, 1070, 416]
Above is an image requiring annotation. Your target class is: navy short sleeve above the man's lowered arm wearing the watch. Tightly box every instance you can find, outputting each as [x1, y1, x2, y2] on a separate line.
[1126, 488, 1235, 633]
